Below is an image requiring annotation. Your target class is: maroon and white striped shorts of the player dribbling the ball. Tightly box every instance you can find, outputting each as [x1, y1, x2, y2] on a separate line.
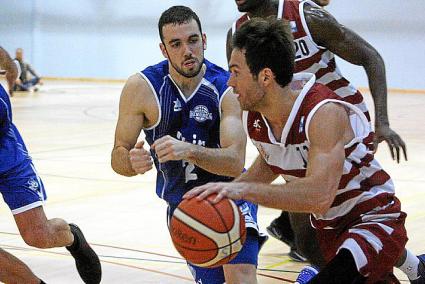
[318, 197, 407, 283]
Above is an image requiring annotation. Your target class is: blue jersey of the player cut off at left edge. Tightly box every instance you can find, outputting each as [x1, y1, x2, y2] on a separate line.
[0, 85, 31, 174]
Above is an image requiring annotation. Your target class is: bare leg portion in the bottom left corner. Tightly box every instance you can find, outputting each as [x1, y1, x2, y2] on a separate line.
[0, 249, 44, 284]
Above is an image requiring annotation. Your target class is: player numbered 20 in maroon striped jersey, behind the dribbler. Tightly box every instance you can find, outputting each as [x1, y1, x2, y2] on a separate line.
[226, 0, 407, 270]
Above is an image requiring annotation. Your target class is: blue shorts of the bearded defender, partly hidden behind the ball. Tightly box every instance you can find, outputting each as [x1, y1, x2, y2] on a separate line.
[167, 201, 265, 284]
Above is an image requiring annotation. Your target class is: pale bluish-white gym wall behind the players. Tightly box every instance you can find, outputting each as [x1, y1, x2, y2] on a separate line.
[0, 0, 425, 89]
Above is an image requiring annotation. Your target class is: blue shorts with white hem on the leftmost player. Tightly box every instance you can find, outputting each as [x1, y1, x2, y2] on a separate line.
[0, 162, 47, 215]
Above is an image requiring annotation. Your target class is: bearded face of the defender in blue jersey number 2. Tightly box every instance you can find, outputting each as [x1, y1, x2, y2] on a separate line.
[160, 20, 206, 78]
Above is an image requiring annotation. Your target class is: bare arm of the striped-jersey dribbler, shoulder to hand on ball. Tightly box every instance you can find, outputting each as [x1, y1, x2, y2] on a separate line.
[184, 104, 353, 214]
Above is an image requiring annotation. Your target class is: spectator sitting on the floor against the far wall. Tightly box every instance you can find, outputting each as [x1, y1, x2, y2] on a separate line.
[14, 48, 42, 92]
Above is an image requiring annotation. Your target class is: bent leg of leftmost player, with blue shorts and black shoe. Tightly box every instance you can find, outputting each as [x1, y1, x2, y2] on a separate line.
[0, 163, 101, 283]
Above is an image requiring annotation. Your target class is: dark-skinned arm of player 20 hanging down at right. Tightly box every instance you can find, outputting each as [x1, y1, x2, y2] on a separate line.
[304, 5, 407, 161]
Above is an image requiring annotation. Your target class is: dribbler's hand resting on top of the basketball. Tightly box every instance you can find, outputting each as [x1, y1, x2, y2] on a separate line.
[183, 182, 245, 203]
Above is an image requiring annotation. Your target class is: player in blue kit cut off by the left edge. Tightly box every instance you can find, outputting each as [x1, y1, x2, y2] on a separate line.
[0, 47, 101, 284]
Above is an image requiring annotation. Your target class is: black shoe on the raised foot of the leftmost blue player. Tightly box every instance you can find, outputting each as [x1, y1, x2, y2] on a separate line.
[66, 224, 102, 284]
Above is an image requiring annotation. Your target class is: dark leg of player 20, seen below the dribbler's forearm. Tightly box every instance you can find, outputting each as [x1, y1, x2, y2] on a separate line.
[289, 213, 325, 268]
